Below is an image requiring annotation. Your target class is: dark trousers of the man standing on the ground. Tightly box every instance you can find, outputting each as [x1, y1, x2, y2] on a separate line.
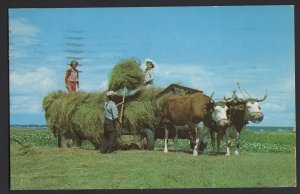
[100, 118, 117, 153]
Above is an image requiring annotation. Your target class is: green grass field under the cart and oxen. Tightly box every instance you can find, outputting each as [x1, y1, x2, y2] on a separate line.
[10, 129, 296, 190]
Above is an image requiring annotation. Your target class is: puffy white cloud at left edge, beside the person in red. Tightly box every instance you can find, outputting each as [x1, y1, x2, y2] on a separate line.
[10, 67, 58, 94]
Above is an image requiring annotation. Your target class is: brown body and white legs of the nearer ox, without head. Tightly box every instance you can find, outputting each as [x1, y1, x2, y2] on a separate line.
[162, 93, 213, 156]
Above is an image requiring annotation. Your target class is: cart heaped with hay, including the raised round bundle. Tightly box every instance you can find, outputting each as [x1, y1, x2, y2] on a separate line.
[43, 59, 202, 150]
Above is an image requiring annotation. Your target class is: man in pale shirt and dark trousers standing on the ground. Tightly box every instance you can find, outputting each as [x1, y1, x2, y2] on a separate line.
[100, 91, 119, 154]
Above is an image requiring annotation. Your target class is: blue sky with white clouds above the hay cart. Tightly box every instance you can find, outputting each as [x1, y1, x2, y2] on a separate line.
[9, 5, 295, 126]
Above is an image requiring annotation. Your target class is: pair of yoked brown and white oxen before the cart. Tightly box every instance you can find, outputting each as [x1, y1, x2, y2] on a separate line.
[162, 91, 267, 156]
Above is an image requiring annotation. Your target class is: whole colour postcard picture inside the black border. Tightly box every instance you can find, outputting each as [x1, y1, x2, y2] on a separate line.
[8, 1, 297, 190]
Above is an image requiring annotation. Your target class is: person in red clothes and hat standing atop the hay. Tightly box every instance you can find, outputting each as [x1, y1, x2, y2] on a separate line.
[65, 60, 79, 94]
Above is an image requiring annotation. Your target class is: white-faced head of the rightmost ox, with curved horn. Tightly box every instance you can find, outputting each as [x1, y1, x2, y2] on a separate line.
[244, 93, 267, 123]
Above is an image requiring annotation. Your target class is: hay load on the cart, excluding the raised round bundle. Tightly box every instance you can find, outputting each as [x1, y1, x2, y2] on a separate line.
[43, 87, 165, 148]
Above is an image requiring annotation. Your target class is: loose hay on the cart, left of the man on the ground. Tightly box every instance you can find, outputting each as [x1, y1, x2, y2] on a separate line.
[43, 91, 106, 148]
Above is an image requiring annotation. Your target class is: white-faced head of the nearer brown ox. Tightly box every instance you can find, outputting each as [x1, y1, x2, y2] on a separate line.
[212, 100, 230, 127]
